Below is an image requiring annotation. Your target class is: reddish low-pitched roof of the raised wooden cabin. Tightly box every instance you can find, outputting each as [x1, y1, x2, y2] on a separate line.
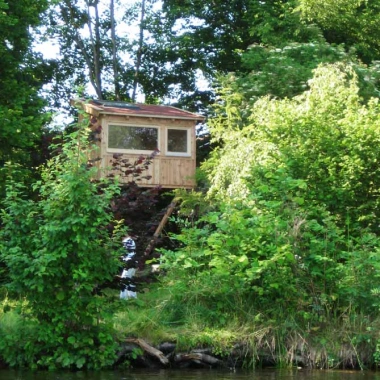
[73, 99, 205, 121]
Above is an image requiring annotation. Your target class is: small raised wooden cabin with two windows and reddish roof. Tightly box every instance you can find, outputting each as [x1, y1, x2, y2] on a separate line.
[72, 99, 204, 189]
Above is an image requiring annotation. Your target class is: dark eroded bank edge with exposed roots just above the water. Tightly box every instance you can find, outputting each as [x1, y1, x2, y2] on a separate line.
[115, 332, 376, 370]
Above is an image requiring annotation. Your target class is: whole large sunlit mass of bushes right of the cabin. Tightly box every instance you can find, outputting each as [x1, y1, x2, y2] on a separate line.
[162, 64, 380, 328]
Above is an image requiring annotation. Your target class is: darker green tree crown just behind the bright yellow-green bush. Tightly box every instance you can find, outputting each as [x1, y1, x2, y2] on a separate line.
[209, 40, 380, 148]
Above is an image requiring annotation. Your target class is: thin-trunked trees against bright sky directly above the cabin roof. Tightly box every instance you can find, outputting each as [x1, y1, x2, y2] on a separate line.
[46, 0, 209, 105]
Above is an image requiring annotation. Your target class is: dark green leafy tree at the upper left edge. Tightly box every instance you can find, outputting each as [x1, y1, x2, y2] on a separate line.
[0, 0, 51, 199]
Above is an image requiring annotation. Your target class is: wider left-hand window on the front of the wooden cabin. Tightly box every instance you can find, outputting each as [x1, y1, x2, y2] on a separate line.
[108, 124, 158, 153]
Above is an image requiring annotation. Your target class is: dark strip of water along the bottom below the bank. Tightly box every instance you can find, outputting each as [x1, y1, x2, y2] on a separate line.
[0, 369, 380, 380]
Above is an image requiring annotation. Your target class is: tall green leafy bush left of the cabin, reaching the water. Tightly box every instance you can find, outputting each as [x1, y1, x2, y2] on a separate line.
[0, 114, 125, 368]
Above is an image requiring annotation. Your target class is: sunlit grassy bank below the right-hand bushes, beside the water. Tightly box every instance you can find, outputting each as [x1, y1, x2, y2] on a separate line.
[113, 284, 380, 369]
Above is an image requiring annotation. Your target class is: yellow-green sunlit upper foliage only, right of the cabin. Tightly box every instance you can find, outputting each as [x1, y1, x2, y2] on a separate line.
[204, 65, 378, 227]
